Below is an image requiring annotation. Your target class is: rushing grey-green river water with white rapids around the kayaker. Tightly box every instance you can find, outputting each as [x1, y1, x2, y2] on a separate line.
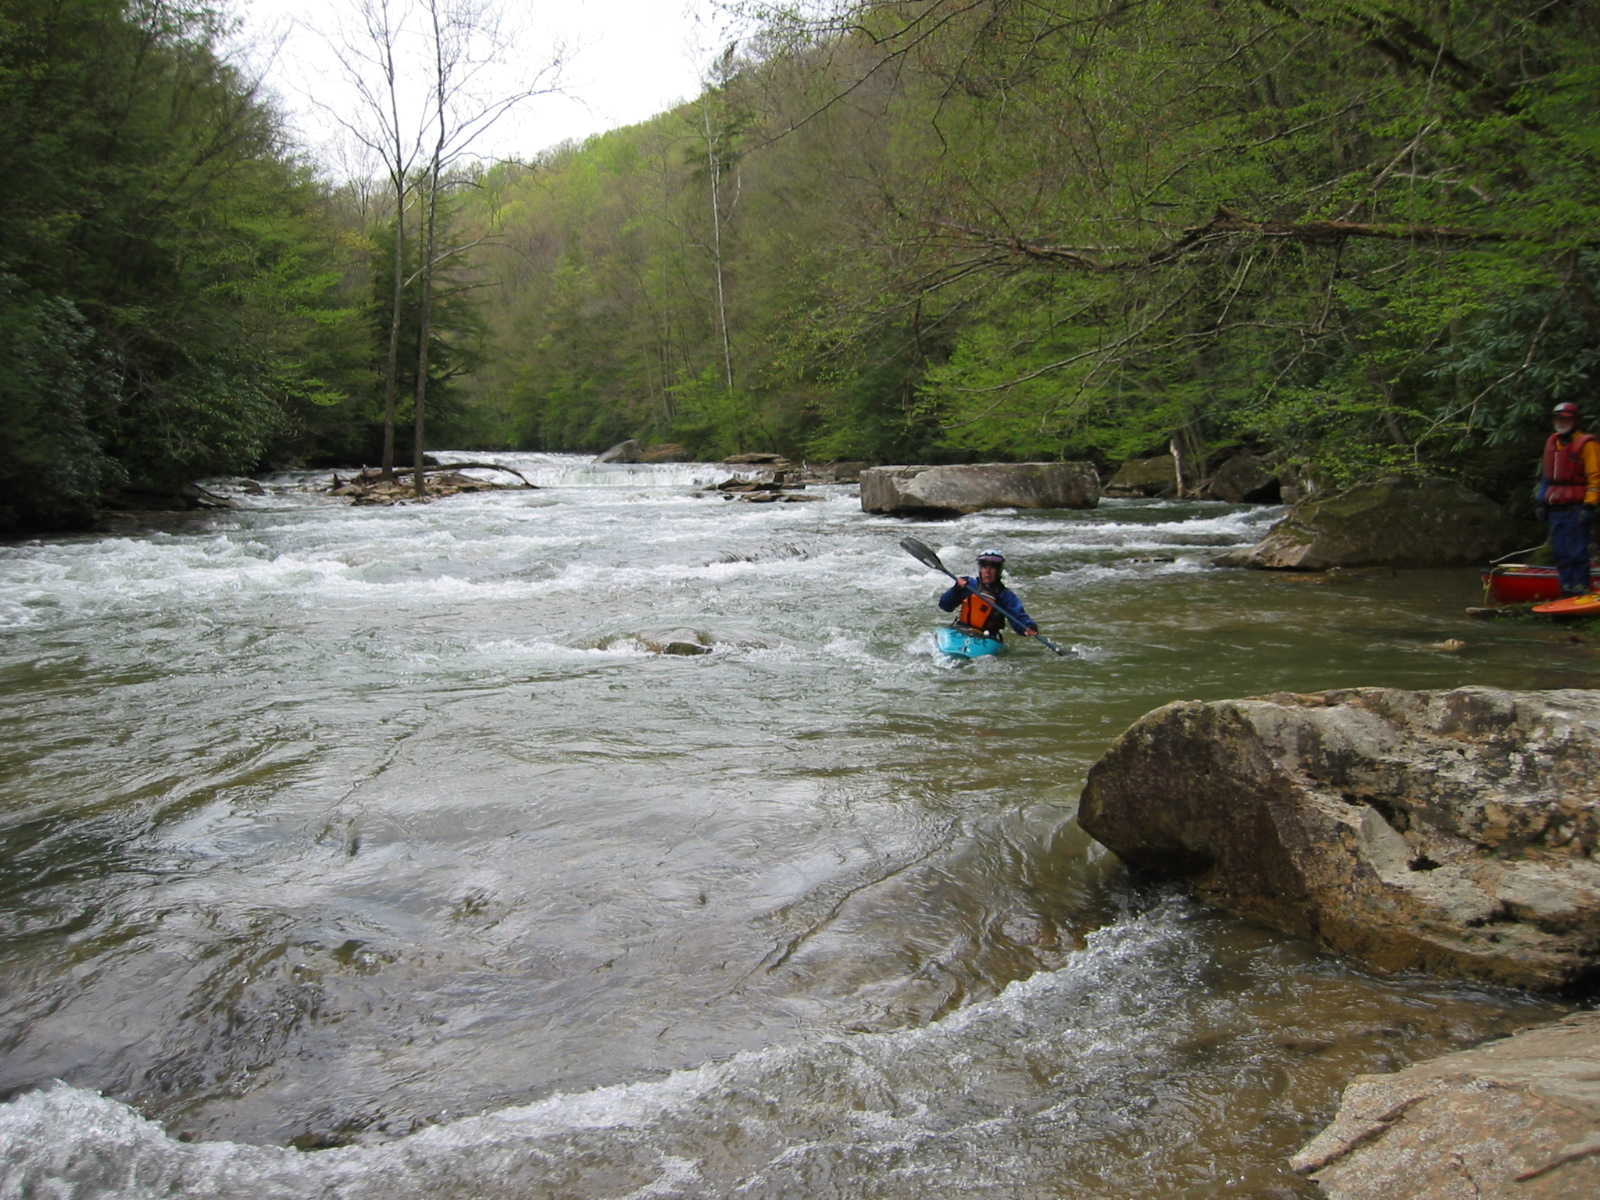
[0, 454, 1574, 1200]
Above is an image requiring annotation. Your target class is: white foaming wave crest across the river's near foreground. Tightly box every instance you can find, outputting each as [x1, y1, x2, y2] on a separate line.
[0, 907, 1202, 1200]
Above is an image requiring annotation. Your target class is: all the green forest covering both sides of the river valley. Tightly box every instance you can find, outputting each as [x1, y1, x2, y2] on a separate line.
[0, 0, 1600, 526]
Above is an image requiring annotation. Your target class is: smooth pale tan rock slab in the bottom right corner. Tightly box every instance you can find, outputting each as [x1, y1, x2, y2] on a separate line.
[1293, 1013, 1600, 1200]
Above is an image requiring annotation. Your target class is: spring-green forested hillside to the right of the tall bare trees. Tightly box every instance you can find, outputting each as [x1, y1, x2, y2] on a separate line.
[454, 0, 1600, 489]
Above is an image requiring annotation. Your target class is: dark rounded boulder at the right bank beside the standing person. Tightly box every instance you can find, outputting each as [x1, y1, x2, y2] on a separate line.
[1216, 478, 1523, 571]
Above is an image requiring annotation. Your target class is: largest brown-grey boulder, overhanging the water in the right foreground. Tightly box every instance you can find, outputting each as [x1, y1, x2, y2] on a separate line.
[1078, 688, 1600, 994]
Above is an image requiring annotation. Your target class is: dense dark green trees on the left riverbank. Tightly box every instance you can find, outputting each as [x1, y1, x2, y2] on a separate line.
[0, 0, 368, 526]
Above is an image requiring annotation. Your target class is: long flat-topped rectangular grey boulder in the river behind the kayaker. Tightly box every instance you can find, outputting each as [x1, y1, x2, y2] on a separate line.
[861, 462, 1099, 517]
